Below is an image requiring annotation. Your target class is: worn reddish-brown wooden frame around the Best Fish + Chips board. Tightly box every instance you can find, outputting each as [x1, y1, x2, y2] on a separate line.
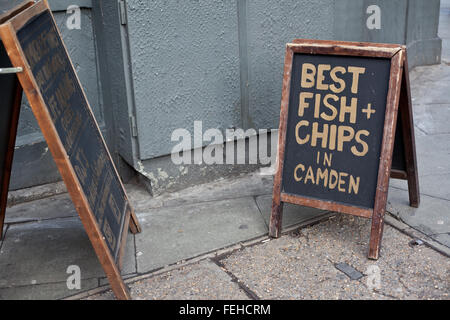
[269, 39, 419, 259]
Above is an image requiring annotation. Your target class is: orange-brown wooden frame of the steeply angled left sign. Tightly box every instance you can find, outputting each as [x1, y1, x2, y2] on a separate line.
[0, 0, 140, 299]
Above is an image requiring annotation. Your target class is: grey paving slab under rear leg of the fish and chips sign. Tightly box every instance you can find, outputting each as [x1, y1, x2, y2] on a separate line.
[387, 188, 450, 240]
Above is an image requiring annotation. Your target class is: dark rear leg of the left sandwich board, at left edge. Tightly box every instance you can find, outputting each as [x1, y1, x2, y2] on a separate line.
[0, 83, 22, 239]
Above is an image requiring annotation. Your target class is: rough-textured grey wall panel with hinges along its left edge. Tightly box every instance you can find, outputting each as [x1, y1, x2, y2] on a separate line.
[127, 0, 240, 160]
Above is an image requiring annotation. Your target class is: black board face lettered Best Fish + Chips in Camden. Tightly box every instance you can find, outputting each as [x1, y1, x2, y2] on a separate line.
[282, 53, 391, 209]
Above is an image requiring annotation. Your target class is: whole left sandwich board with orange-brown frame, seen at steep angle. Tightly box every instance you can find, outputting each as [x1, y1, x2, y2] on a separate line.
[0, 0, 140, 299]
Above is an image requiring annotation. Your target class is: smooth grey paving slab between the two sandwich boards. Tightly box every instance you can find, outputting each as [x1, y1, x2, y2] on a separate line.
[136, 197, 268, 273]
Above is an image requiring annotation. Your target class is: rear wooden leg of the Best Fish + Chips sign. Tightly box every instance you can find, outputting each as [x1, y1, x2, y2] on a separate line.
[399, 57, 420, 208]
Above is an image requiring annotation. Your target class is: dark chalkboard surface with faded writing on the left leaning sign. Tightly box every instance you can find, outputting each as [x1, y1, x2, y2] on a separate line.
[17, 11, 131, 260]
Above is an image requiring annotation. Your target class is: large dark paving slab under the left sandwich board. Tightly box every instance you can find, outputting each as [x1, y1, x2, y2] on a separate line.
[0, 218, 136, 288]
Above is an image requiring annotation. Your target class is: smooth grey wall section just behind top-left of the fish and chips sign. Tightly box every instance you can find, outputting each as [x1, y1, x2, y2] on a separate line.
[247, 0, 334, 129]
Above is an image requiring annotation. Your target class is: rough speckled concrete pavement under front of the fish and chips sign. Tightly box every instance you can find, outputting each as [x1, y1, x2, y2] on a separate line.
[85, 215, 450, 300]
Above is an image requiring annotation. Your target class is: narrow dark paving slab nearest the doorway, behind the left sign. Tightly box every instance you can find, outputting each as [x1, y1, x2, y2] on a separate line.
[5, 193, 78, 223]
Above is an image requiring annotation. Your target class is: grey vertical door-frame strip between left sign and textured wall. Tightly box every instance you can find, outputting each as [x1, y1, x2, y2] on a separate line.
[93, 1, 137, 169]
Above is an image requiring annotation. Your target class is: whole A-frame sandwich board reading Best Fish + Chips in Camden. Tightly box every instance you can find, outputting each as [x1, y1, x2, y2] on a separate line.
[270, 39, 419, 259]
